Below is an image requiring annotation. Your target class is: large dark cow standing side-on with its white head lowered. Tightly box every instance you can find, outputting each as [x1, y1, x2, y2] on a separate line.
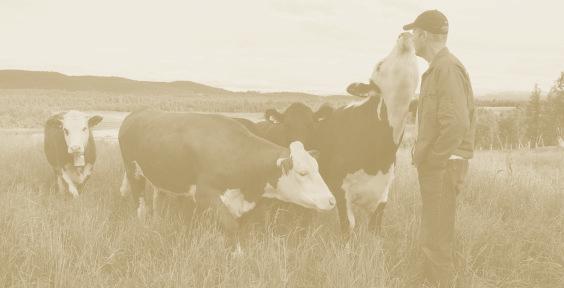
[118, 110, 335, 235]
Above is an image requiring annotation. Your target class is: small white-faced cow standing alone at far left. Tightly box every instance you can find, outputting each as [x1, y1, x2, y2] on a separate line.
[44, 110, 103, 198]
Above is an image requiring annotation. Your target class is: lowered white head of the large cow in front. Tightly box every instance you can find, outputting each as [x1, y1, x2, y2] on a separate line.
[263, 141, 335, 210]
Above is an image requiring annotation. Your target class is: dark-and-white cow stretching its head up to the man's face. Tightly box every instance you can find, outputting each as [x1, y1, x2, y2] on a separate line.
[314, 33, 418, 235]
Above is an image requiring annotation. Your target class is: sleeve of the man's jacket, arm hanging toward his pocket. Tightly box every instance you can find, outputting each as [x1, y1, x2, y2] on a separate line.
[426, 67, 470, 166]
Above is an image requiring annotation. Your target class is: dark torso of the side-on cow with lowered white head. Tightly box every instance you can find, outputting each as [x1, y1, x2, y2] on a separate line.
[118, 110, 280, 193]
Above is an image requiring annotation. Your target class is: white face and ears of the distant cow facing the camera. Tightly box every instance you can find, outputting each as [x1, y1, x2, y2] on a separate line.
[47, 110, 102, 166]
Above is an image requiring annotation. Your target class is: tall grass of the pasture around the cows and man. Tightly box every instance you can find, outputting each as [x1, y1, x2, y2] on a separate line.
[0, 136, 564, 288]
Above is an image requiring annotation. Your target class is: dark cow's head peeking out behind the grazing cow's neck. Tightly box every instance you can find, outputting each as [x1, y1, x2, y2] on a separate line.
[264, 103, 316, 148]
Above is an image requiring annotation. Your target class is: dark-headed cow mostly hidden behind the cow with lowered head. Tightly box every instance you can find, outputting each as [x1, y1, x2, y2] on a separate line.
[235, 102, 318, 149]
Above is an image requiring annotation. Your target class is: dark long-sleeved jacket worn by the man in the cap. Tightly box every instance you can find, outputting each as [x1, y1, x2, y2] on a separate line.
[413, 47, 476, 167]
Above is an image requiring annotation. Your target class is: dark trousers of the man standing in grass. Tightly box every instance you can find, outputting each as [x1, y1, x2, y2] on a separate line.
[417, 159, 468, 288]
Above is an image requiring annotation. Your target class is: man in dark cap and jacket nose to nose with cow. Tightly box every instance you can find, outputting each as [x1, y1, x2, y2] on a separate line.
[403, 10, 475, 287]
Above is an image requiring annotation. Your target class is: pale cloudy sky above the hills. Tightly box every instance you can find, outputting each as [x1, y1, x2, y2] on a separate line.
[0, 0, 564, 94]
